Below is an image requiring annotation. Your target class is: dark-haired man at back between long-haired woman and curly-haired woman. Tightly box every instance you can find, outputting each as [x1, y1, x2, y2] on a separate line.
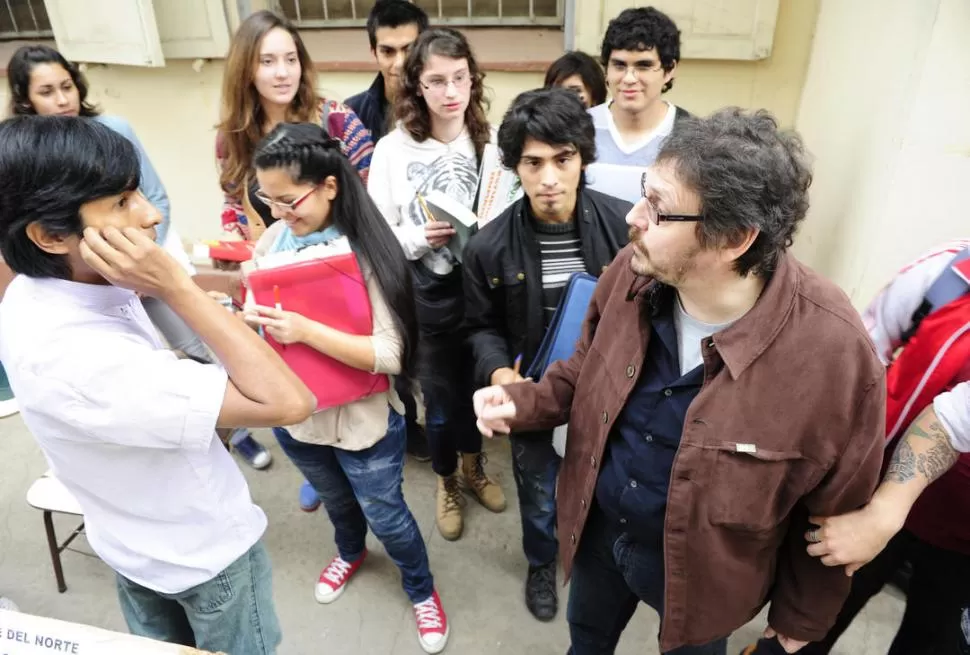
[345, 0, 428, 143]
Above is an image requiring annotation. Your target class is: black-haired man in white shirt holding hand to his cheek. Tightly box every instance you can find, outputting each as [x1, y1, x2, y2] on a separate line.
[0, 116, 316, 654]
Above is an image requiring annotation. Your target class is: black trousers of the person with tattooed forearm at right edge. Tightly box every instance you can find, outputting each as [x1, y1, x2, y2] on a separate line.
[799, 532, 970, 655]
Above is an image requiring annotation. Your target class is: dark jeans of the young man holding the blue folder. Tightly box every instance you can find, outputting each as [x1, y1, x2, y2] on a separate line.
[509, 432, 561, 566]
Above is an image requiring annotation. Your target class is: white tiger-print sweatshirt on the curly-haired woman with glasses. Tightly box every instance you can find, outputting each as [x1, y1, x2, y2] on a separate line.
[367, 127, 484, 275]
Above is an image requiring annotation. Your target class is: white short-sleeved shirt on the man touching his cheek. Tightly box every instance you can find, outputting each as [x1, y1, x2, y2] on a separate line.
[0, 275, 266, 593]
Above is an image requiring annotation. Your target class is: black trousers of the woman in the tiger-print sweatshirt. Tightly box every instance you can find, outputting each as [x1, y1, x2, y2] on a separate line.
[418, 330, 482, 476]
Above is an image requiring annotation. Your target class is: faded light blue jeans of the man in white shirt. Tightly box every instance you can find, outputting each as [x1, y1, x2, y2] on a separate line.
[117, 541, 282, 655]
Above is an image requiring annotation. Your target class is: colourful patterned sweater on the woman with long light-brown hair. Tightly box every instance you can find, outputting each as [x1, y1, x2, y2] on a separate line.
[216, 99, 374, 239]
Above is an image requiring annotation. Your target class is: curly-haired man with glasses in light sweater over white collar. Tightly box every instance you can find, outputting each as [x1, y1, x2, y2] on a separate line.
[589, 7, 688, 202]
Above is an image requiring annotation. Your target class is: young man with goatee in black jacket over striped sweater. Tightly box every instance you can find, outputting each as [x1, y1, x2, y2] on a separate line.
[464, 88, 631, 621]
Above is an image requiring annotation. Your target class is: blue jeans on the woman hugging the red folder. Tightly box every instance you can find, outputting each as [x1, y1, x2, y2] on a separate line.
[273, 410, 434, 603]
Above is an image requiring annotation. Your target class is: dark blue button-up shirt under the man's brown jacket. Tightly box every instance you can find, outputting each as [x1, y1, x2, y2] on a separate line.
[596, 289, 704, 548]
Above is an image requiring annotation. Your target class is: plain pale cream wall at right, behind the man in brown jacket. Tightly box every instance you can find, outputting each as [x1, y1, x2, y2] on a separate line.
[796, 0, 970, 307]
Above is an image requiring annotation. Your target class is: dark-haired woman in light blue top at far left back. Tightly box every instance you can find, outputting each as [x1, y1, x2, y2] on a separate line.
[7, 45, 272, 469]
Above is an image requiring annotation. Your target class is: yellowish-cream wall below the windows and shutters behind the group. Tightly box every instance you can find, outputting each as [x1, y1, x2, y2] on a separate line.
[2, 0, 819, 246]
